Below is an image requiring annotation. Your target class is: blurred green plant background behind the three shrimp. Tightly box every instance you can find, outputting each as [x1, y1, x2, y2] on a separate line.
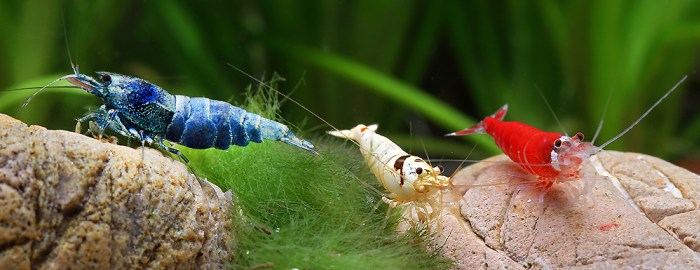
[0, 0, 700, 171]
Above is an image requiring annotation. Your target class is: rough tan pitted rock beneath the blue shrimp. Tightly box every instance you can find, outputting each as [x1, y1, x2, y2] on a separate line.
[0, 114, 231, 269]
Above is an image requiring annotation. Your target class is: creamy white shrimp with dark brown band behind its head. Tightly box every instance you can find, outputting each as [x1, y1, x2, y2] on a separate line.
[328, 125, 454, 224]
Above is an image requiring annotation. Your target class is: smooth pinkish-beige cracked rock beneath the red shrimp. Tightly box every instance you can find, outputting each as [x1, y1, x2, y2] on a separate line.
[422, 151, 700, 269]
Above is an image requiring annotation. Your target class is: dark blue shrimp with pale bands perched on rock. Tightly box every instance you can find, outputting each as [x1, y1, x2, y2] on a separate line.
[39, 68, 318, 163]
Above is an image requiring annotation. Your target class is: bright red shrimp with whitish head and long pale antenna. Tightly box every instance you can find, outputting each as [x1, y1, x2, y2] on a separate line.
[446, 76, 687, 192]
